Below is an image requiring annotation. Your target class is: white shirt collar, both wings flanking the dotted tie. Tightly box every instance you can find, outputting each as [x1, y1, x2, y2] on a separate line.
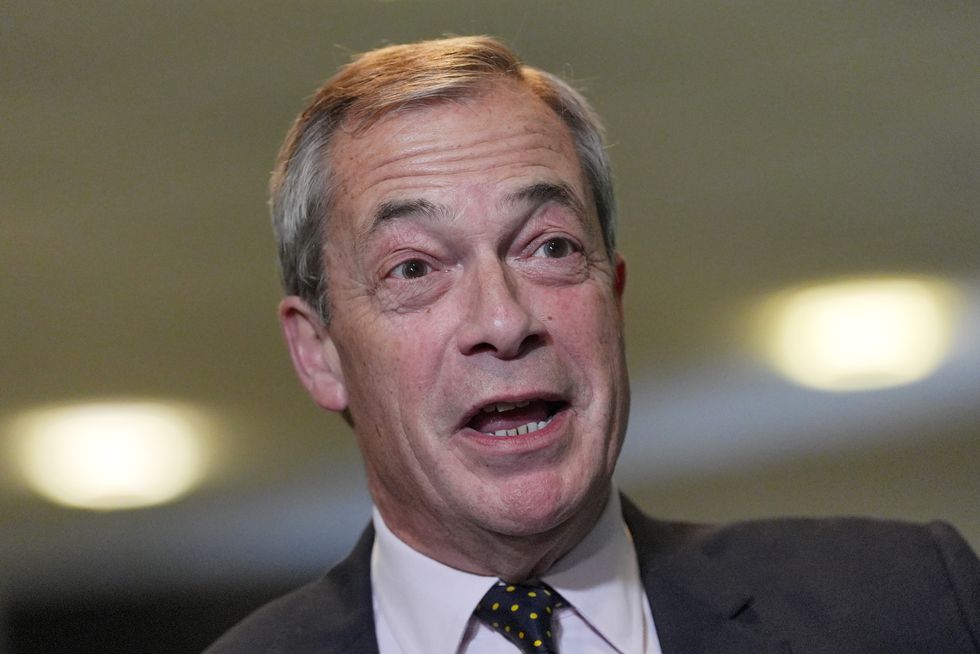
[371, 489, 646, 654]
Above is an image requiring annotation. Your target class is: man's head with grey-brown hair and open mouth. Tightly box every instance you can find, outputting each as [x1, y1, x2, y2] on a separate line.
[272, 38, 629, 570]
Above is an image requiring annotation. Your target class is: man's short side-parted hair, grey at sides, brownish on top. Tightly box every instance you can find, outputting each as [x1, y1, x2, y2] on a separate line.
[270, 36, 616, 324]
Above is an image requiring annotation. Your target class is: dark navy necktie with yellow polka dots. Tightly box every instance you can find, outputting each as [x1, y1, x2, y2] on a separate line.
[473, 581, 565, 654]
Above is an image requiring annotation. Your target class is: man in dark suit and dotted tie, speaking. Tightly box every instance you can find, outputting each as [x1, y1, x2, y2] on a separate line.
[209, 37, 980, 654]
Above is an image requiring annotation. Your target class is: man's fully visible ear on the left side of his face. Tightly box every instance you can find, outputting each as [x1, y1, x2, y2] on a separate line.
[279, 295, 347, 411]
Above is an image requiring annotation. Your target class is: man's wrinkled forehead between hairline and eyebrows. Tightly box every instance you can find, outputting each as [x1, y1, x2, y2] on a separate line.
[331, 83, 589, 231]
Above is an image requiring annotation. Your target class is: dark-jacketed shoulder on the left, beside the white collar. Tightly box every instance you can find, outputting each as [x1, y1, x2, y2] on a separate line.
[205, 527, 377, 654]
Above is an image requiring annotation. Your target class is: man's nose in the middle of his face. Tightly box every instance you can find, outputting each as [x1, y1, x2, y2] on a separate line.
[458, 260, 544, 359]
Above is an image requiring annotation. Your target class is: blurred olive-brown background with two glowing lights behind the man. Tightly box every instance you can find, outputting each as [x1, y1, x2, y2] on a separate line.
[0, 0, 980, 654]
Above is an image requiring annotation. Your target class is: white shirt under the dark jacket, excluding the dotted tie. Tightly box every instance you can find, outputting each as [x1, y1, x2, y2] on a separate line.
[371, 490, 661, 654]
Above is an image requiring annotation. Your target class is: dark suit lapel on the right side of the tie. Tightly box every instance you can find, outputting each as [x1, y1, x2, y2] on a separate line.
[622, 497, 792, 654]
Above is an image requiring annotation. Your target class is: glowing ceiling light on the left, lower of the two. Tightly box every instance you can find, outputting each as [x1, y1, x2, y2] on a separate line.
[14, 402, 211, 510]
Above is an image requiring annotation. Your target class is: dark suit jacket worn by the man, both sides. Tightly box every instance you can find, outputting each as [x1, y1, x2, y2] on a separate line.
[206, 498, 980, 654]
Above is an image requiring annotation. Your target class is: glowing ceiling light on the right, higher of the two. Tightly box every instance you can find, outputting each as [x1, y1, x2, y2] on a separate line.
[763, 277, 954, 391]
